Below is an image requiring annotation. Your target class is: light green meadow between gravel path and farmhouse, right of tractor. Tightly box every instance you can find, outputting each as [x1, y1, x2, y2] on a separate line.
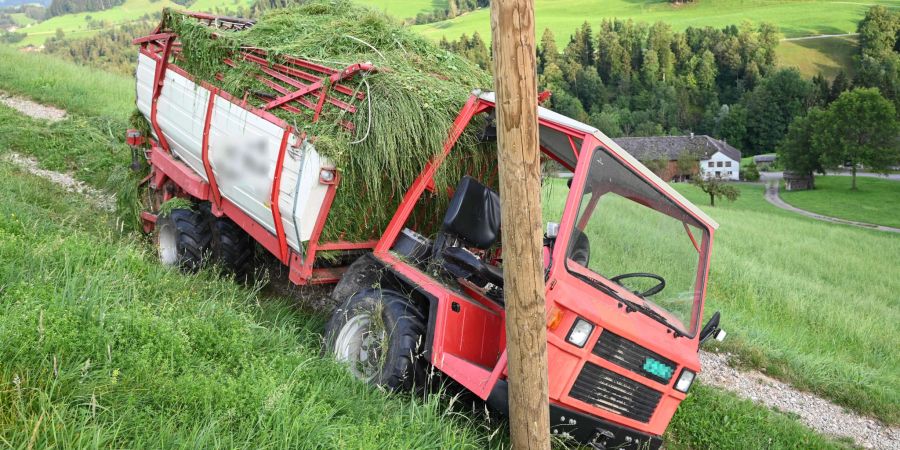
[545, 178, 900, 424]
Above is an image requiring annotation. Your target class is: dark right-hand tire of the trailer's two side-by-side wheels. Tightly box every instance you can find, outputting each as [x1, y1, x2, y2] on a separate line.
[210, 217, 256, 283]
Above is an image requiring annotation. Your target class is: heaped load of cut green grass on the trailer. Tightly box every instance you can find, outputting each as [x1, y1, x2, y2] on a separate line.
[164, 0, 494, 241]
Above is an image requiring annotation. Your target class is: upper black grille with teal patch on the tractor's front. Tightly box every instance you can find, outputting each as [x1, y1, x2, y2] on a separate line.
[593, 330, 676, 384]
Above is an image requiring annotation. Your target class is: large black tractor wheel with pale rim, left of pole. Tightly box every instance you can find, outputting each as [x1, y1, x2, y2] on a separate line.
[325, 289, 428, 391]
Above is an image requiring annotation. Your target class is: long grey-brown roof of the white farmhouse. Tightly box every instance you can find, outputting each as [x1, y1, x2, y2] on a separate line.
[615, 135, 741, 161]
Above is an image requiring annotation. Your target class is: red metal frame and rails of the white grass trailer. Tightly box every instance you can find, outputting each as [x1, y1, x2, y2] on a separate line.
[133, 12, 377, 284]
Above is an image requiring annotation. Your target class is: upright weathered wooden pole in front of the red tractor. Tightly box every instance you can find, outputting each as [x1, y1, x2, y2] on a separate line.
[491, 0, 550, 450]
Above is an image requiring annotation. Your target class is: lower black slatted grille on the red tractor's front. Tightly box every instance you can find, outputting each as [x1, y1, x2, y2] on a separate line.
[569, 362, 662, 423]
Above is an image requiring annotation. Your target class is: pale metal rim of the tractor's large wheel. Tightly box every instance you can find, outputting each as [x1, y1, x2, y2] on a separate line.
[334, 314, 386, 382]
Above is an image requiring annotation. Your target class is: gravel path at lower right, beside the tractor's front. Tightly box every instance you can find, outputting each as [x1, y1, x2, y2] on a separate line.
[699, 351, 900, 449]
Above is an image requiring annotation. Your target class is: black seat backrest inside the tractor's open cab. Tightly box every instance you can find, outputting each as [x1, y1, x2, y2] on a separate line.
[441, 176, 500, 250]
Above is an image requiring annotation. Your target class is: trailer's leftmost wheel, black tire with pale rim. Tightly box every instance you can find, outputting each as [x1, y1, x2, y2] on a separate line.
[154, 209, 211, 273]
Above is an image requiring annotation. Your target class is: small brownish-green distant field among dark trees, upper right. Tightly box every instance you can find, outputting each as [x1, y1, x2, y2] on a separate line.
[776, 36, 859, 79]
